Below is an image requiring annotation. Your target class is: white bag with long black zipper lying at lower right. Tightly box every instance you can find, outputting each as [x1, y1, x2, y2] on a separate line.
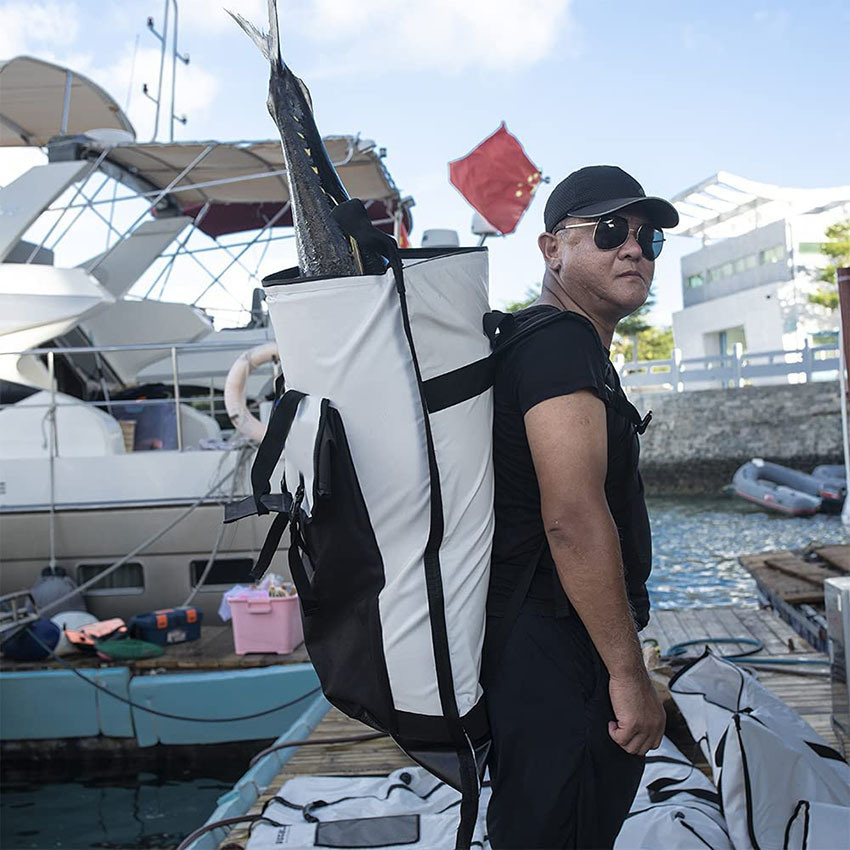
[670, 653, 850, 850]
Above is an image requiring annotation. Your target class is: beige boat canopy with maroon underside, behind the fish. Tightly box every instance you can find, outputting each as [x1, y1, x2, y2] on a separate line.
[89, 136, 411, 238]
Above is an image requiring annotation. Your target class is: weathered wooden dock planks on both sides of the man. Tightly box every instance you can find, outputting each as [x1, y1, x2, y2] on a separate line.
[221, 607, 839, 850]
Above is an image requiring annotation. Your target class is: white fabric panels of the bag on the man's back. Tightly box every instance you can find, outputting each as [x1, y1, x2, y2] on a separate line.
[266, 250, 493, 717]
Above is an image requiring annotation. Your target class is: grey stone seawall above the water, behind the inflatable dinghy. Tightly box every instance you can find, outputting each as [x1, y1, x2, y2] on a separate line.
[629, 381, 844, 495]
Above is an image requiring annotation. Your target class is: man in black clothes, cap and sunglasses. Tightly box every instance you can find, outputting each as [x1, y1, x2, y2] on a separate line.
[483, 166, 678, 848]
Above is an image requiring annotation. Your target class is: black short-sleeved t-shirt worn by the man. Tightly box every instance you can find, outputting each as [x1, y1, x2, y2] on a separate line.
[488, 305, 652, 628]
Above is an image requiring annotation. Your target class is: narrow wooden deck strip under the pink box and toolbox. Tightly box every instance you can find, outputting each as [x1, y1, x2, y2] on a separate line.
[0, 624, 310, 673]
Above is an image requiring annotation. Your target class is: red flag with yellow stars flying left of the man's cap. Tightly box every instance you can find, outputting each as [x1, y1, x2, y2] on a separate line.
[449, 121, 540, 234]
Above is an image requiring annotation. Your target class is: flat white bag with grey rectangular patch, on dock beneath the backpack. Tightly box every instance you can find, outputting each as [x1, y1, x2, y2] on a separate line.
[246, 767, 490, 850]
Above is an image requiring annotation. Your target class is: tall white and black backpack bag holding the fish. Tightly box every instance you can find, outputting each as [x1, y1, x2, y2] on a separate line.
[222, 209, 494, 844]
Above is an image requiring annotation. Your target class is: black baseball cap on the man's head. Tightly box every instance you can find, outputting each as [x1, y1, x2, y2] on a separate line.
[543, 165, 679, 233]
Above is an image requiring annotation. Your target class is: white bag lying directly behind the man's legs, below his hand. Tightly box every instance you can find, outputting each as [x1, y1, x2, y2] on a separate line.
[614, 738, 732, 850]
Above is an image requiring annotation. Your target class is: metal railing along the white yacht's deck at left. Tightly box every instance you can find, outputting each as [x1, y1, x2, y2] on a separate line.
[0, 340, 278, 456]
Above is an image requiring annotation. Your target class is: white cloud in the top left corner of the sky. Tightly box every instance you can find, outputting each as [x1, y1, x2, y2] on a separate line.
[0, 0, 80, 59]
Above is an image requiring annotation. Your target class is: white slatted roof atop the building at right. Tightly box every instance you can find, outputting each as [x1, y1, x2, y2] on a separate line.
[670, 171, 850, 239]
